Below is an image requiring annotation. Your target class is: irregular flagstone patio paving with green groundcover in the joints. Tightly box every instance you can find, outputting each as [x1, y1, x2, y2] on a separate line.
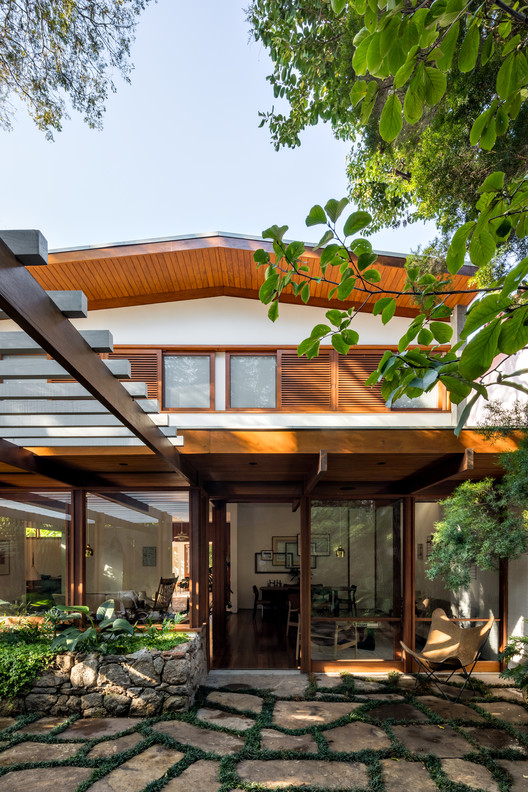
[0, 671, 528, 792]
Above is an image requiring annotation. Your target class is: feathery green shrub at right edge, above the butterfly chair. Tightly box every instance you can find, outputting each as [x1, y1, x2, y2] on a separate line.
[427, 470, 528, 590]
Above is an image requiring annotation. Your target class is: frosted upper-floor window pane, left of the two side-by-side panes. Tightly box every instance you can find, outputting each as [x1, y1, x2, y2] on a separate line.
[163, 355, 211, 410]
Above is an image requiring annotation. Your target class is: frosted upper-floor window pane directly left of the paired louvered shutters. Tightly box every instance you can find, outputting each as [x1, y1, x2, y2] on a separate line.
[230, 355, 277, 409]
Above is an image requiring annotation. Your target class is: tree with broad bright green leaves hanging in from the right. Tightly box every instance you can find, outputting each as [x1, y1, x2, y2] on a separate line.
[250, 0, 528, 430]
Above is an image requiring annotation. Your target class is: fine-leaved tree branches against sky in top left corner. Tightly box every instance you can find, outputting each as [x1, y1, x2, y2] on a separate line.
[0, 0, 149, 139]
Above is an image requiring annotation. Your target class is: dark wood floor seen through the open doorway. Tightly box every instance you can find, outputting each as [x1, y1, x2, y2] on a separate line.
[213, 610, 297, 668]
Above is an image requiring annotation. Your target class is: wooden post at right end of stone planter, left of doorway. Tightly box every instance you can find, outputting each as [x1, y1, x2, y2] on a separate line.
[189, 487, 209, 627]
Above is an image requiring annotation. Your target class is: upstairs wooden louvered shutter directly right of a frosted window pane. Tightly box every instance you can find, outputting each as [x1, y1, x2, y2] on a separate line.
[278, 350, 332, 412]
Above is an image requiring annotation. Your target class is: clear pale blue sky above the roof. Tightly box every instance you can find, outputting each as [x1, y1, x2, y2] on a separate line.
[0, 0, 434, 253]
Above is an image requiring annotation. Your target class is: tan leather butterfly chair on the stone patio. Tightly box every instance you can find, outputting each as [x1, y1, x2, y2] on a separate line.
[400, 608, 494, 701]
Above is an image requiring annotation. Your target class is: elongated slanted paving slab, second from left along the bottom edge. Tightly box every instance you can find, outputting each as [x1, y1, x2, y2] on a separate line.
[90, 745, 185, 792]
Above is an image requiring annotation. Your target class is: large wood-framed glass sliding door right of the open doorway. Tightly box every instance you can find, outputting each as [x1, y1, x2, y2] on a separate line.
[310, 500, 402, 663]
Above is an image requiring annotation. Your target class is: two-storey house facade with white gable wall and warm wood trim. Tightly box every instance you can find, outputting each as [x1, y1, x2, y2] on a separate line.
[0, 234, 526, 671]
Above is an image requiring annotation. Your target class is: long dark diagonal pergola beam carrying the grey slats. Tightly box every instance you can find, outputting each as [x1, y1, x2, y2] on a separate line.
[0, 239, 194, 482]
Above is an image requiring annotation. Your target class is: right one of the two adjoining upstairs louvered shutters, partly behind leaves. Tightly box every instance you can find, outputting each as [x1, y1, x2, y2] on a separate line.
[337, 350, 387, 412]
